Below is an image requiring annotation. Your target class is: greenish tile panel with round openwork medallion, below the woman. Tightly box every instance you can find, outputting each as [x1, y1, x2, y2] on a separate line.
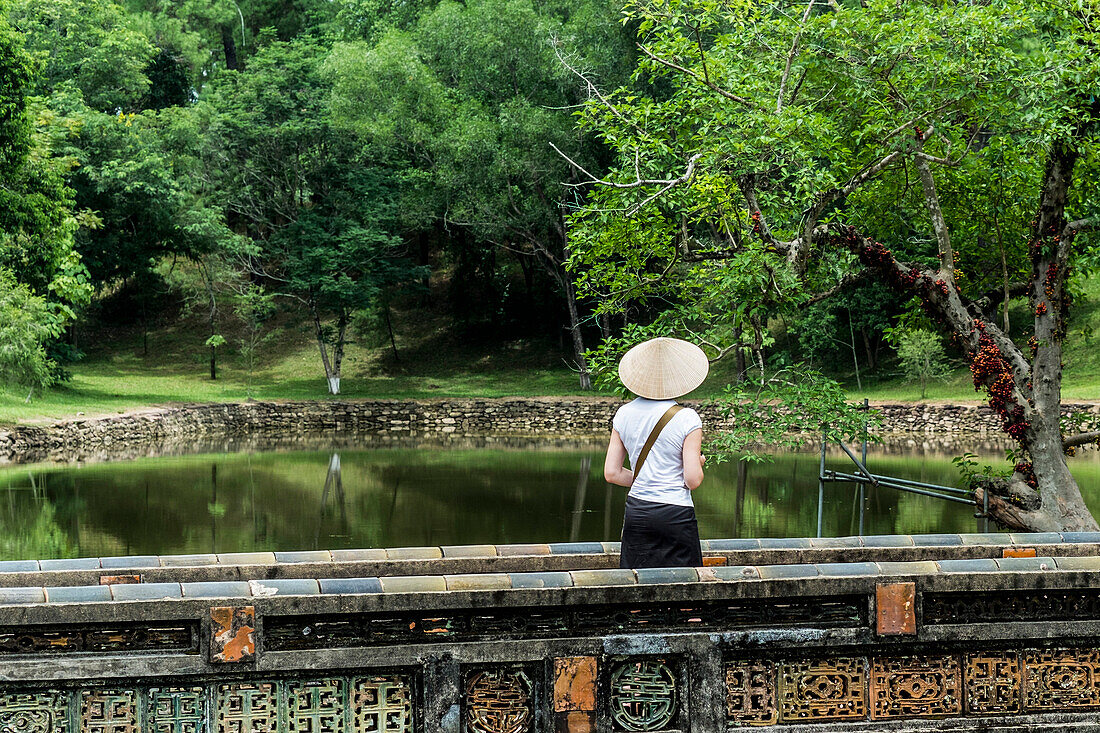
[611, 659, 677, 731]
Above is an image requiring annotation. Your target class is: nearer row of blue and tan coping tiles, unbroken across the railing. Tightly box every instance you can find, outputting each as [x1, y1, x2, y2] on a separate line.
[0, 556, 1100, 605]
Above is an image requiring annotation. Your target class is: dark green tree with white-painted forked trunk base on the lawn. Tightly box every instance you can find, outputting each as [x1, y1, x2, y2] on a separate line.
[196, 35, 419, 394]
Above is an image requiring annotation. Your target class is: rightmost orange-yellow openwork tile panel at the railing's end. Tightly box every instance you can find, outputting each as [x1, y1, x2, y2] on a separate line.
[1022, 649, 1100, 712]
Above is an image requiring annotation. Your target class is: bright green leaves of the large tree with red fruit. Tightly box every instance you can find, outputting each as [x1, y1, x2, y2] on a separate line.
[570, 0, 1100, 451]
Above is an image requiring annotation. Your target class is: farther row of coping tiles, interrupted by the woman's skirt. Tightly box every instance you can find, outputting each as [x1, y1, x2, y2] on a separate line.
[0, 532, 1100, 573]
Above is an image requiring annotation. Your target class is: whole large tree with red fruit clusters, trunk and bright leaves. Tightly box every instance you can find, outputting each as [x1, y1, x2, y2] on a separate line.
[574, 0, 1100, 529]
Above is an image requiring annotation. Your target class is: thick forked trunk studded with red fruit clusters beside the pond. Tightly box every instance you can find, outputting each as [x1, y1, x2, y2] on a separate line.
[839, 134, 1098, 530]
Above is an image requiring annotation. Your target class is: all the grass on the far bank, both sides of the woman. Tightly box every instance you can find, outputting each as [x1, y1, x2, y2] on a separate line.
[0, 278, 1100, 425]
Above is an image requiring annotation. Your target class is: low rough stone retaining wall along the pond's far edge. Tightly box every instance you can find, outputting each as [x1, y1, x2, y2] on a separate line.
[0, 397, 1100, 463]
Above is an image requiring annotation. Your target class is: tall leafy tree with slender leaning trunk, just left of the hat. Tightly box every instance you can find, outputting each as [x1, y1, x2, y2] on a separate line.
[329, 0, 630, 390]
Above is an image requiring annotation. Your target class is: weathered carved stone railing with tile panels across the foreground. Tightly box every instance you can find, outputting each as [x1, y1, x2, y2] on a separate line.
[0, 535, 1100, 733]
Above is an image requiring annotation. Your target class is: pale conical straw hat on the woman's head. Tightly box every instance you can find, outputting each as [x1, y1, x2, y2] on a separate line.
[619, 337, 711, 400]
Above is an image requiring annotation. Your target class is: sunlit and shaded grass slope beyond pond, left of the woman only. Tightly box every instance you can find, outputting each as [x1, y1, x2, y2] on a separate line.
[0, 301, 611, 425]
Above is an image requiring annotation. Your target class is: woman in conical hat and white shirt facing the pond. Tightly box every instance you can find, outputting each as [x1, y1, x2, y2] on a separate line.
[604, 338, 710, 568]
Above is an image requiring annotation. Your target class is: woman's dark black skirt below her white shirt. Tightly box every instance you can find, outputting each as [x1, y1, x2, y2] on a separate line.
[619, 496, 703, 568]
